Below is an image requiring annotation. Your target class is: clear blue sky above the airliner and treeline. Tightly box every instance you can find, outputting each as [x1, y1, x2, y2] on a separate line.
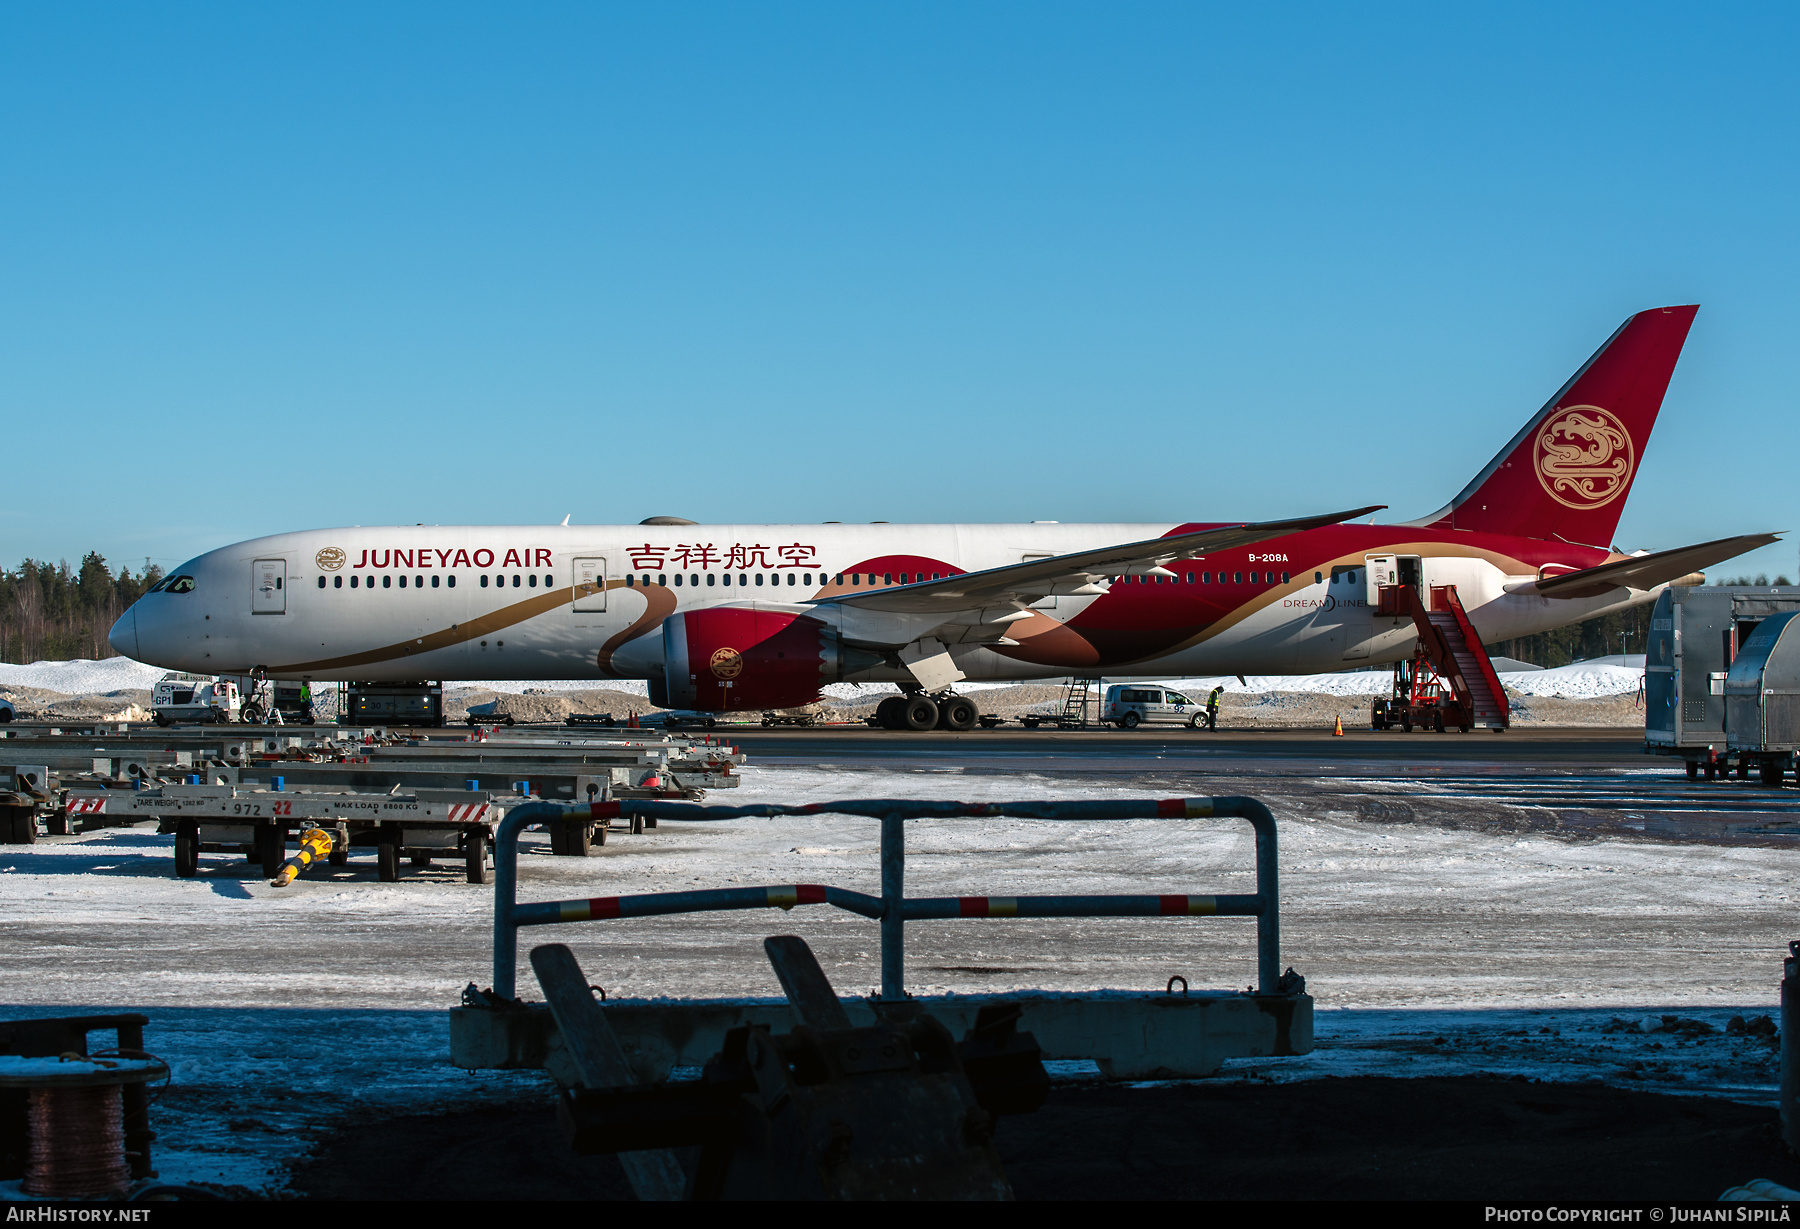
[0, 4, 1800, 574]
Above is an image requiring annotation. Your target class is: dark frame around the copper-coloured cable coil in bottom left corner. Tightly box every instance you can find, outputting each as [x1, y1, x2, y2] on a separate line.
[0, 1015, 167, 1182]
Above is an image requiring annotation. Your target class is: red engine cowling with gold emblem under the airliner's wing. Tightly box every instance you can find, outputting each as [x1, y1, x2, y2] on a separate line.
[662, 605, 842, 713]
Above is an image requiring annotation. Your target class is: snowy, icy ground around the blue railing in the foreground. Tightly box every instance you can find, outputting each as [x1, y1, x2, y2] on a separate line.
[0, 765, 1800, 1189]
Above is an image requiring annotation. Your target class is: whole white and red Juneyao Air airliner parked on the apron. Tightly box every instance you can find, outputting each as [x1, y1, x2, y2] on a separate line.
[110, 306, 1775, 725]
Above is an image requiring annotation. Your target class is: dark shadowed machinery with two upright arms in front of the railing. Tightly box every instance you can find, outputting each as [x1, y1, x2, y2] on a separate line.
[531, 936, 1049, 1200]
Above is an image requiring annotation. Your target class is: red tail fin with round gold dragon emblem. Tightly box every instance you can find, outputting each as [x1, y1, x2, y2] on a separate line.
[1413, 306, 1699, 549]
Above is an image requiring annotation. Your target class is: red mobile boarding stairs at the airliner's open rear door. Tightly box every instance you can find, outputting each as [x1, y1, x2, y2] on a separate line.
[1370, 585, 1512, 734]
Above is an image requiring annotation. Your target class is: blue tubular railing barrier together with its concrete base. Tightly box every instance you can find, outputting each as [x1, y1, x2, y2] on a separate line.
[450, 797, 1312, 1083]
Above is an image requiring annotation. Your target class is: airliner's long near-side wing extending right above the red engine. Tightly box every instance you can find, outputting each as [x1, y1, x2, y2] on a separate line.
[819, 504, 1386, 615]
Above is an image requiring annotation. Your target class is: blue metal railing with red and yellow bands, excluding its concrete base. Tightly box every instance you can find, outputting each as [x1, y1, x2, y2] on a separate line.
[493, 797, 1282, 999]
